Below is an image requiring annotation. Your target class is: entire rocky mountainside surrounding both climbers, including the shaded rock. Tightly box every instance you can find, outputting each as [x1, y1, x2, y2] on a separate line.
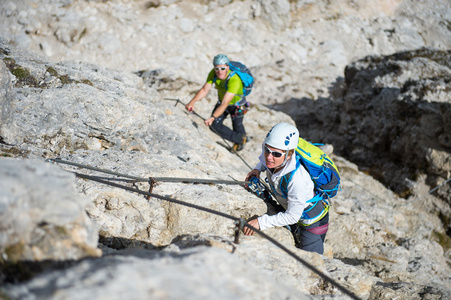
[0, 0, 451, 299]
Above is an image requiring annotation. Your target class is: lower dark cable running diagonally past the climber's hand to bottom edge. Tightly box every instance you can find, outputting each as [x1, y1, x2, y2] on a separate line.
[59, 166, 360, 300]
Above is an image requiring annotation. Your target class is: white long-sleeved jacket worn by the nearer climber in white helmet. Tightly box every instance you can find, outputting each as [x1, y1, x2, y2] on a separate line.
[254, 152, 314, 230]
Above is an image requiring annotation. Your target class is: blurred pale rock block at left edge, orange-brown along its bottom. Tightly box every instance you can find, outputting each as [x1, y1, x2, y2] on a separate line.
[0, 158, 102, 262]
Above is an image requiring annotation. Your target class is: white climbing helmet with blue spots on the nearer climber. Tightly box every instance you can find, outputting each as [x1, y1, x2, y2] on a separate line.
[265, 123, 299, 150]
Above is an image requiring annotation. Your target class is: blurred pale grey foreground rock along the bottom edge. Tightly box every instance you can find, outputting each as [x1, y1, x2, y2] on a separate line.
[4, 246, 311, 300]
